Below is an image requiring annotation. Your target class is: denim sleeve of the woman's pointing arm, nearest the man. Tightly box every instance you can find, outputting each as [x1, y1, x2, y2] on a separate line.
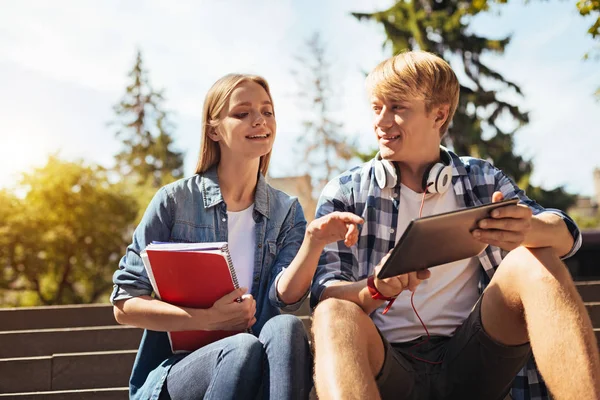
[269, 200, 309, 312]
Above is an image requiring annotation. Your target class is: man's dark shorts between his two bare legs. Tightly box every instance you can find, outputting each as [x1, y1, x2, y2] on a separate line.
[377, 296, 531, 400]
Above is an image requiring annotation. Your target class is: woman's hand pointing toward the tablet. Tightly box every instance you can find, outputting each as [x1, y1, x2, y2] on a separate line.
[306, 211, 365, 247]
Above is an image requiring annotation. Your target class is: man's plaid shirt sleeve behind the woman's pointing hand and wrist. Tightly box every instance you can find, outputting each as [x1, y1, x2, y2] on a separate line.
[310, 180, 358, 308]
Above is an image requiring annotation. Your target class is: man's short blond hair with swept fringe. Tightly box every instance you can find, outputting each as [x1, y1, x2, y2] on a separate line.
[366, 51, 460, 135]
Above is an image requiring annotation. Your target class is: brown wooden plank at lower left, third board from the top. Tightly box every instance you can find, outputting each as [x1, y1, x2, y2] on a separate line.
[0, 350, 137, 393]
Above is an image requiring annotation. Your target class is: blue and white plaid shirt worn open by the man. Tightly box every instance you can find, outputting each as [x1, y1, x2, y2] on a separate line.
[311, 152, 581, 400]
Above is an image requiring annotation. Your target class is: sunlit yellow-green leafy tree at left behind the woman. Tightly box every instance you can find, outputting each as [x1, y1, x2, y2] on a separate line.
[0, 156, 137, 305]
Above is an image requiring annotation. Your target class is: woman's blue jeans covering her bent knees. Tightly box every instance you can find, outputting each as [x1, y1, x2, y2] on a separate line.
[161, 315, 312, 400]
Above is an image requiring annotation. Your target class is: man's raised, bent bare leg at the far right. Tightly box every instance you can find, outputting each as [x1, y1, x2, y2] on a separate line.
[481, 247, 600, 400]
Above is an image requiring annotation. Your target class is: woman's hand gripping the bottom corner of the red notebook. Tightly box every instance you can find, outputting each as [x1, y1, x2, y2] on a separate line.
[207, 288, 256, 331]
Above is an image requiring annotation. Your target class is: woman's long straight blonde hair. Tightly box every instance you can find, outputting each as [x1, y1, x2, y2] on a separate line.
[196, 74, 275, 176]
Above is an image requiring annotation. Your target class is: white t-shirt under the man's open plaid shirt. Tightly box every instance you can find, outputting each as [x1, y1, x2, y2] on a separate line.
[372, 185, 480, 343]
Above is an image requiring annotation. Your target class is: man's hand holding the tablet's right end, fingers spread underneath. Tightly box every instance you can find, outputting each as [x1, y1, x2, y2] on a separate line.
[473, 192, 533, 251]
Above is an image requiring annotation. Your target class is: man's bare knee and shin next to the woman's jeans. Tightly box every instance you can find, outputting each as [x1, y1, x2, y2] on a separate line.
[312, 299, 385, 400]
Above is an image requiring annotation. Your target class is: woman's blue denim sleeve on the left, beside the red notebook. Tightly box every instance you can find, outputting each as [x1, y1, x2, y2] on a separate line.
[110, 188, 173, 304]
